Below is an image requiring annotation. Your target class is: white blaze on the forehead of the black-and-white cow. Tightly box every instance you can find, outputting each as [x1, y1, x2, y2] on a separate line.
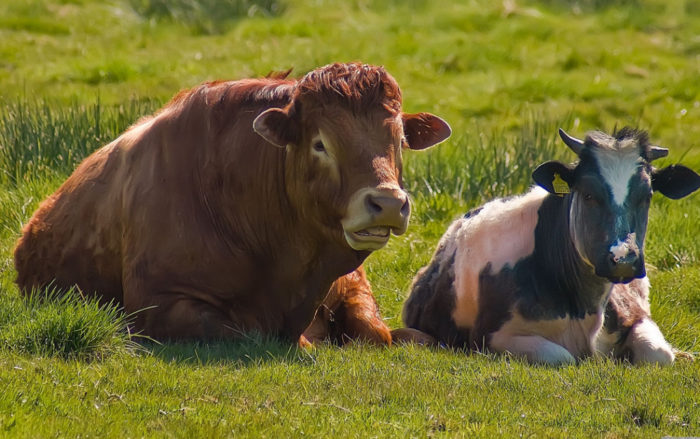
[593, 139, 642, 206]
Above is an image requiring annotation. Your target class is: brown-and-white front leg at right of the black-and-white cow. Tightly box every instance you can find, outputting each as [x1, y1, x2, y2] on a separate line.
[597, 277, 675, 365]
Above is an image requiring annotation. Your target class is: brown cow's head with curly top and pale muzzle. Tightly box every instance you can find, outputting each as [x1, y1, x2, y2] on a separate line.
[253, 63, 451, 251]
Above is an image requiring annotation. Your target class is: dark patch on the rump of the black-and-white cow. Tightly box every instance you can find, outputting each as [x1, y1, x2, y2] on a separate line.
[403, 248, 469, 347]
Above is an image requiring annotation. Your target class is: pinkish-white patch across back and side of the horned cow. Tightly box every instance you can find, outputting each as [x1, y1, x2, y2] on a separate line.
[448, 187, 548, 327]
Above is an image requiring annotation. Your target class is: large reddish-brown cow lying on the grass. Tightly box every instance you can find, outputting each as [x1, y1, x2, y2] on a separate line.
[15, 63, 450, 340]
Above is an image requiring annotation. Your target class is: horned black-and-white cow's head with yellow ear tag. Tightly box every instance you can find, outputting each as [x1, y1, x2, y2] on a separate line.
[533, 127, 700, 283]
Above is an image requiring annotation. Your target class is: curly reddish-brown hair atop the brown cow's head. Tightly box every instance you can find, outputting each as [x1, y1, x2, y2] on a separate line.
[294, 63, 401, 114]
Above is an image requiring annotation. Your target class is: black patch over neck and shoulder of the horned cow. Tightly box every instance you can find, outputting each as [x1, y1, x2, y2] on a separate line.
[471, 195, 610, 348]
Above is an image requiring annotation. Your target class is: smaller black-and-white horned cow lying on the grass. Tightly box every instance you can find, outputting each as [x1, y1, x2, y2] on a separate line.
[395, 128, 700, 364]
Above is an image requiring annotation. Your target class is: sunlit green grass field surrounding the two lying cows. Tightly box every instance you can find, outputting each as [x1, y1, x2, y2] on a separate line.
[0, 0, 700, 438]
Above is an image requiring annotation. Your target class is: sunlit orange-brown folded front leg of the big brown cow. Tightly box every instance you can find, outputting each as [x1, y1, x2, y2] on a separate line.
[299, 266, 391, 346]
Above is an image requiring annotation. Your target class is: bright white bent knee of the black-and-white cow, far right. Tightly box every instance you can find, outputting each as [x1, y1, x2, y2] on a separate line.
[625, 319, 675, 365]
